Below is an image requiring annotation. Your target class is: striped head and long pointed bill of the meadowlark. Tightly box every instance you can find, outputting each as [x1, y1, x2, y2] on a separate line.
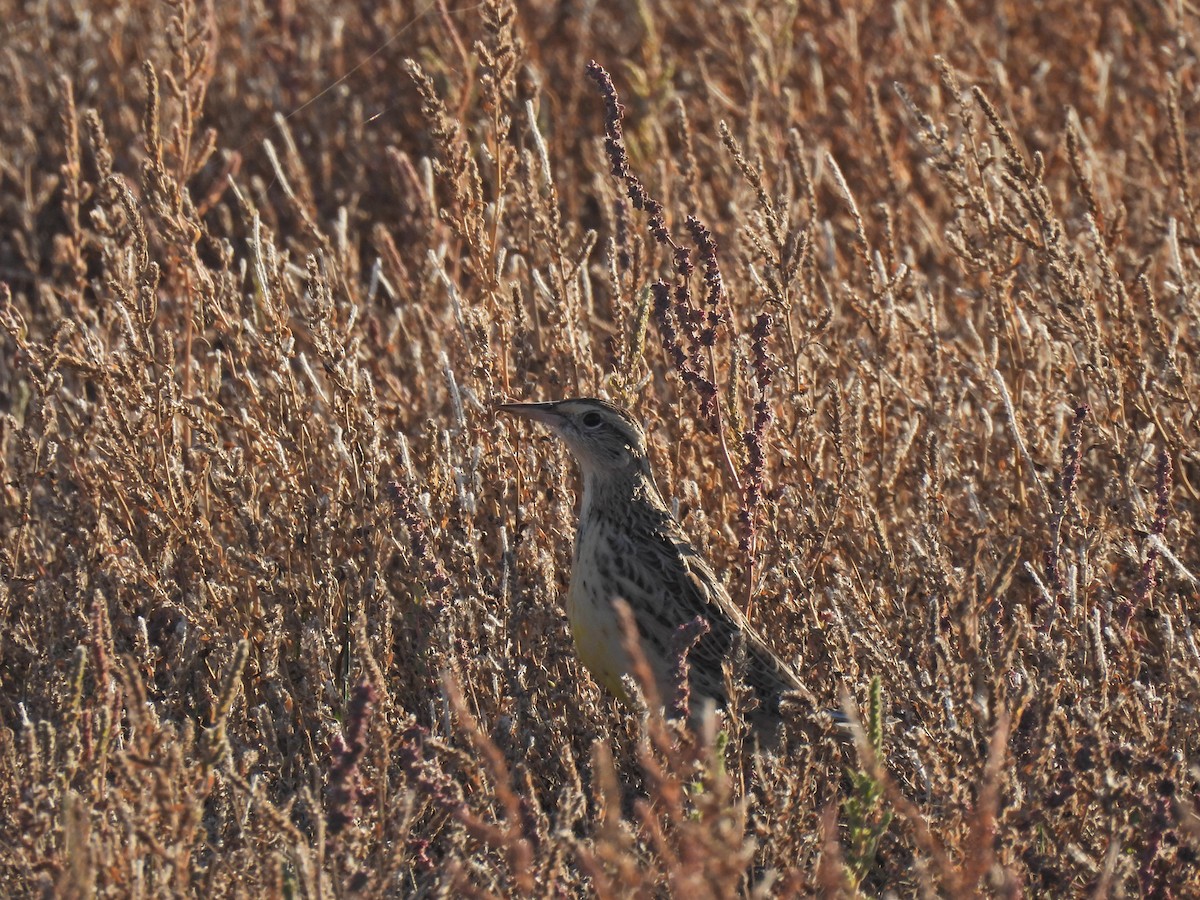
[497, 397, 649, 479]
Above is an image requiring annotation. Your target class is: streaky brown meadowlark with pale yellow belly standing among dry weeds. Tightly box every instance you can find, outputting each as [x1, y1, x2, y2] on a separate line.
[498, 398, 830, 731]
